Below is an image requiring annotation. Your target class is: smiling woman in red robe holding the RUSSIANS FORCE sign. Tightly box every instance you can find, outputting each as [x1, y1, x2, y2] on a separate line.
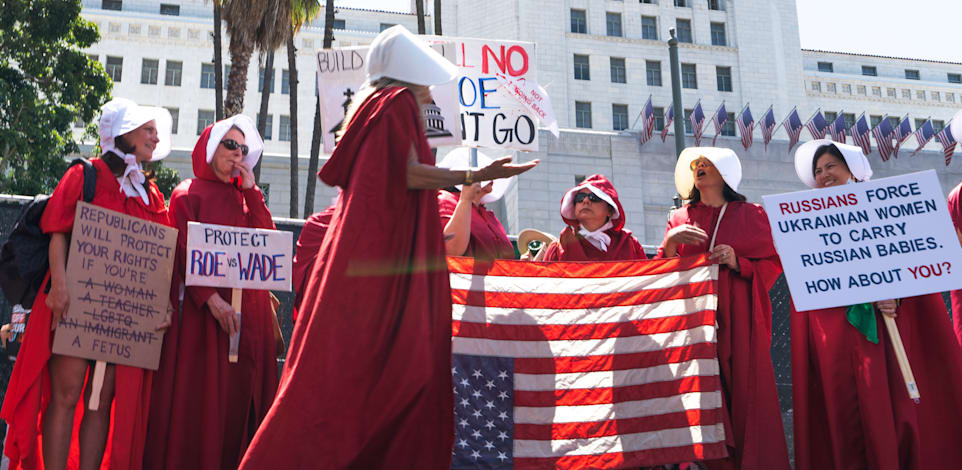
[791, 140, 962, 470]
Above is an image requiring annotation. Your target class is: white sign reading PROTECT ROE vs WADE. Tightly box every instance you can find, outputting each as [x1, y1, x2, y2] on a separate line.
[185, 222, 294, 291]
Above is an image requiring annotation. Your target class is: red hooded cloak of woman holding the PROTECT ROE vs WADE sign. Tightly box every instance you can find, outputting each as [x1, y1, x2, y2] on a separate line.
[144, 126, 277, 470]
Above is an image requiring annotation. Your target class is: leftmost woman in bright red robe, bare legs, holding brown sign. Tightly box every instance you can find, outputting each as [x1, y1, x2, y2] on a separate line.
[0, 98, 171, 470]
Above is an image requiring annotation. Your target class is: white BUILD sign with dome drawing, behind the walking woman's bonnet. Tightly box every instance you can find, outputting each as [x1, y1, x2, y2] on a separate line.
[317, 41, 461, 153]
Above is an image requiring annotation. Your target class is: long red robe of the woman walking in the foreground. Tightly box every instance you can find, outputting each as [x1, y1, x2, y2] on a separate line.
[240, 87, 454, 470]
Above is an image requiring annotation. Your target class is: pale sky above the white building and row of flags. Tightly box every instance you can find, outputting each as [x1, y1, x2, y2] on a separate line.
[336, 0, 962, 63]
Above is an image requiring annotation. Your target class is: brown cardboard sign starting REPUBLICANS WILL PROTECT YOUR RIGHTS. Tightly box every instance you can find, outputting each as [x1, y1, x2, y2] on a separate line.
[53, 201, 177, 370]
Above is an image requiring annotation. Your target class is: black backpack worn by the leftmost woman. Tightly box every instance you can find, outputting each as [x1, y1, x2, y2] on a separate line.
[0, 158, 97, 310]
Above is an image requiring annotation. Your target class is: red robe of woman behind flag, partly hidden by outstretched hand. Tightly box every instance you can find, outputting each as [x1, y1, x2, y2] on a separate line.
[438, 190, 514, 260]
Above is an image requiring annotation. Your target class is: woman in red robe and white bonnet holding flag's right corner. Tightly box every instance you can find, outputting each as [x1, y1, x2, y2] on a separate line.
[658, 147, 789, 470]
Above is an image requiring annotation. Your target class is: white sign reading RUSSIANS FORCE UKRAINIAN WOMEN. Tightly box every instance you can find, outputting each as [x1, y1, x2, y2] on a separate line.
[763, 170, 962, 311]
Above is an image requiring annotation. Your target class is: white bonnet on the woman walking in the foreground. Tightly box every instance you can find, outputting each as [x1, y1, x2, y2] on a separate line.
[367, 25, 458, 86]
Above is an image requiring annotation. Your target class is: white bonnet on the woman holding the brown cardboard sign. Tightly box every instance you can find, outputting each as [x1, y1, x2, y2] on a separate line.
[97, 98, 173, 161]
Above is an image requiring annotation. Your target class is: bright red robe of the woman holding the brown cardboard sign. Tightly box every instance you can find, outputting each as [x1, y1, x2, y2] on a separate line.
[0, 159, 167, 470]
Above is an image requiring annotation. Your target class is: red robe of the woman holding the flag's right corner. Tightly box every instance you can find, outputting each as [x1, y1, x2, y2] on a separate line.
[658, 202, 789, 470]
